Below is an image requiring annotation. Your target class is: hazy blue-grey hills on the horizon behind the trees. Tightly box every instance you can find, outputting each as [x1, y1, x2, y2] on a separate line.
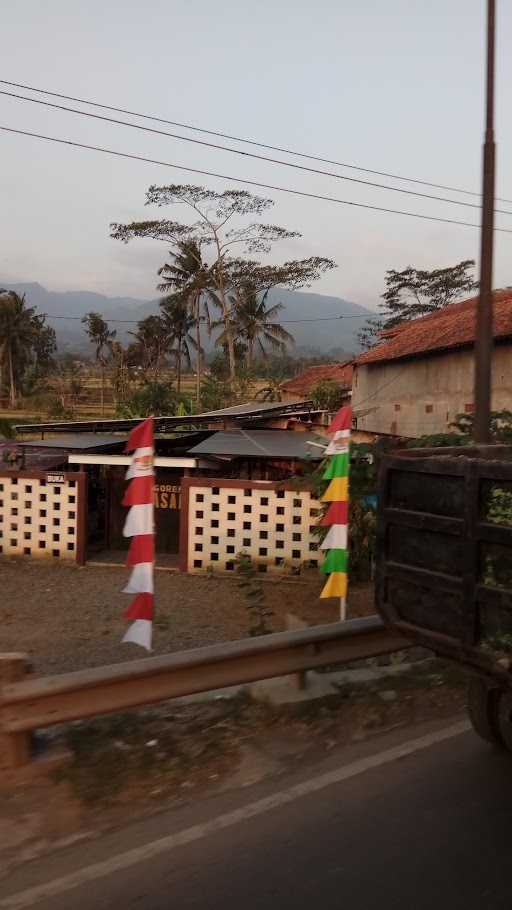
[0, 279, 374, 354]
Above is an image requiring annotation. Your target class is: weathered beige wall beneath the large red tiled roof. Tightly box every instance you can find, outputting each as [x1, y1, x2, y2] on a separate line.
[352, 344, 512, 436]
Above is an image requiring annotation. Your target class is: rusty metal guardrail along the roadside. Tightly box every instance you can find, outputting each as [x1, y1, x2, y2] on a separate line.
[0, 616, 410, 768]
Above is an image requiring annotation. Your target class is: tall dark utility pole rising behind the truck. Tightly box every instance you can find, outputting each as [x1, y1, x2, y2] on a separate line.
[474, 0, 496, 444]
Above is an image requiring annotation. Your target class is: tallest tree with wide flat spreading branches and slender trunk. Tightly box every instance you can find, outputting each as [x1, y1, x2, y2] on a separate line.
[111, 184, 334, 382]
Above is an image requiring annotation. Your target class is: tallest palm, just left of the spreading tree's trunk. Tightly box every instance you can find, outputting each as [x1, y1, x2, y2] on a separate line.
[157, 237, 214, 406]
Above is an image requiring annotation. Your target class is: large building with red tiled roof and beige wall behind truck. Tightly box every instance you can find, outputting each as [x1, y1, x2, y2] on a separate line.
[352, 288, 512, 436]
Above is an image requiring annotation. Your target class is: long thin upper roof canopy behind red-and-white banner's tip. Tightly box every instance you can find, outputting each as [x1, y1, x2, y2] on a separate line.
[15, 401, 316, 433]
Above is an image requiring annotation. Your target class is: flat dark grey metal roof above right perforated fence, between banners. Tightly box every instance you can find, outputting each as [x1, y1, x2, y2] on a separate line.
[189, 430, 326, 460]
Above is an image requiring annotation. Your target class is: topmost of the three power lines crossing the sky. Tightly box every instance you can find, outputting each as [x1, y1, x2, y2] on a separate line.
[4, 79, 512, 204]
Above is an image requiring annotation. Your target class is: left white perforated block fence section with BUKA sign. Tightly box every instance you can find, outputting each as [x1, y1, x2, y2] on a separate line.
[0, 471, 86, 564]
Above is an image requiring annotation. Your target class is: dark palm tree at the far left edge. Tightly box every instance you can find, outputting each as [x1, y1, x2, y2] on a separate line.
[0, 289, 41, 408]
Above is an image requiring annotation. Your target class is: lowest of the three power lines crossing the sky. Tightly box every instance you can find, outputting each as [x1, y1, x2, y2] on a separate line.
[4, 126, 512, 234]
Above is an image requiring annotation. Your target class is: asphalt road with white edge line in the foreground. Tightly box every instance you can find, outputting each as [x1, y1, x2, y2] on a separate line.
[0, 724, 512, 910]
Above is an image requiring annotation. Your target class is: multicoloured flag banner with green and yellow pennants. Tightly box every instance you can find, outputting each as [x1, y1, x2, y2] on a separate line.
[320, 406, 352, 619]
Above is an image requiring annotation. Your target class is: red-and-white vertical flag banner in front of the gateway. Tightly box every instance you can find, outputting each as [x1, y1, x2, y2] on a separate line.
[123, 417, 155, 651]
